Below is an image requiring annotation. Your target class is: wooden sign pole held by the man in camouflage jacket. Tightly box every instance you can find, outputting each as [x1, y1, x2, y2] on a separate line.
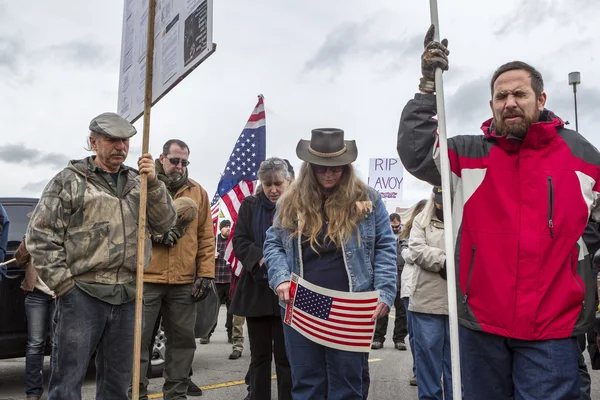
[131, 0, 156, 400]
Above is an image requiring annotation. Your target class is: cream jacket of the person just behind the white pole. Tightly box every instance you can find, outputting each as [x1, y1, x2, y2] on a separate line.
[404, 206, 448, 315]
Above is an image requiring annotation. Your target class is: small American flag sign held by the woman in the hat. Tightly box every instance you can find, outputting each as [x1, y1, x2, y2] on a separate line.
[284, 274, 379, 353]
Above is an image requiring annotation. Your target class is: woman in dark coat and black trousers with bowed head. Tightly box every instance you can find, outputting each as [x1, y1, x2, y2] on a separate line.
[230, 157, 292, 400]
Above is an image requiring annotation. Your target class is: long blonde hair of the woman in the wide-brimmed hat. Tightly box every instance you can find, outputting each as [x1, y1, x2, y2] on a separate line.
[277, 162, 370, 251]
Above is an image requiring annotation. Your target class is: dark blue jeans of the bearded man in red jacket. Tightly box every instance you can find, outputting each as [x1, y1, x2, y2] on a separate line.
[460, 326, 581, 400]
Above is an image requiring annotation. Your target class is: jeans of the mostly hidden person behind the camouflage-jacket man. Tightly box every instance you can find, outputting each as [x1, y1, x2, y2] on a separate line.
[25, 289, 54, 397]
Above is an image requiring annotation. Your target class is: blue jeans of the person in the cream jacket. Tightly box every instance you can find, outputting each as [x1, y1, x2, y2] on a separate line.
[412, 312, 450, 400]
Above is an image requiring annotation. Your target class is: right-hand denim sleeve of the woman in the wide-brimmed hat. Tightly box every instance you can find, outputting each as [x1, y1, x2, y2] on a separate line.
[373, 193, 398, 308]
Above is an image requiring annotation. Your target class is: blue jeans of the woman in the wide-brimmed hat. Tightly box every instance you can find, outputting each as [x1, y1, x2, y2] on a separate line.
[283, 323, 368, 400]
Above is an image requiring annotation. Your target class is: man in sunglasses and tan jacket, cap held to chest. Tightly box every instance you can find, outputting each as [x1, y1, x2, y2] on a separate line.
[134, 139, 215, 399]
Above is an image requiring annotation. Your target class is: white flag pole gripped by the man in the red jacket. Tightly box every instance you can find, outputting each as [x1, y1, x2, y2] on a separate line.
[429, 0, 462, 399]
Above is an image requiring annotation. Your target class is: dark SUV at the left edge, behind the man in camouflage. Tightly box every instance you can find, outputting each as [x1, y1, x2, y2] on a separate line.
[0, 197, 38, 360]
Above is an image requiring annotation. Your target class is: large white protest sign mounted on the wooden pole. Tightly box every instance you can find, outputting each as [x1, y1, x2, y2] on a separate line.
[117, 0, 216, 122]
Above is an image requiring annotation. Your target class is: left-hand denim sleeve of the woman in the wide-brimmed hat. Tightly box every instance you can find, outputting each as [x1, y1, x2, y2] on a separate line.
[263, 211, 292, 290]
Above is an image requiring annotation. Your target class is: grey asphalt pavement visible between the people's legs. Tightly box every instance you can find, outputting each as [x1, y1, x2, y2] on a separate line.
[0, 307, 600, 400]
